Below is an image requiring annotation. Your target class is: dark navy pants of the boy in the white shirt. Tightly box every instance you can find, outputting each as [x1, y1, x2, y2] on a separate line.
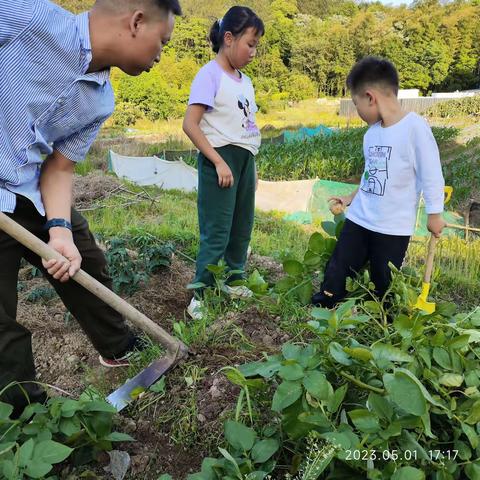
[312, 219, 410, 308]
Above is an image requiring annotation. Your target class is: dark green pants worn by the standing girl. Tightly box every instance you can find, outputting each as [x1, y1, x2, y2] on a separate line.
[195, 145, 255, 293]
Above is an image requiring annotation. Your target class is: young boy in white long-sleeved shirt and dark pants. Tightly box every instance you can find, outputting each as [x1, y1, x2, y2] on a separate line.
[312, 57, 445, 308]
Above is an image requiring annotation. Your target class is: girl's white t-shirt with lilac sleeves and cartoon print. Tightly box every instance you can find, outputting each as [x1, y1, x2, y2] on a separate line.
[188, 60, 261, 155]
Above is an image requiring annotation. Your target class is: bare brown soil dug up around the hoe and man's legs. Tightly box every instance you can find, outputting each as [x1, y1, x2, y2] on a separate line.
[18, 253, 288, 480]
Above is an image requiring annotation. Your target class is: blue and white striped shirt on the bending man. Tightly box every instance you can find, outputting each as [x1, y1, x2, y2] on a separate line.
[0, 0, 114, 215]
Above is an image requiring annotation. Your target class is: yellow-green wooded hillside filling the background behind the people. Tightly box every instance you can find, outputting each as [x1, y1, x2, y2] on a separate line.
[51, 0, 480, 124]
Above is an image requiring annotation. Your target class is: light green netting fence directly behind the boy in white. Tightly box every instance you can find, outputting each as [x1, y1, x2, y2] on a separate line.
[284, 180, 464, 237]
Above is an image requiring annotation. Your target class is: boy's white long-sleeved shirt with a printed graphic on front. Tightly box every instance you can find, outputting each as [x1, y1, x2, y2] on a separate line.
[346, 113, 445, 236]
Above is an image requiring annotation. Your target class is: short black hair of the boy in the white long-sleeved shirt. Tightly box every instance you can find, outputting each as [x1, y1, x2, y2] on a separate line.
[347, 57, 400, 95]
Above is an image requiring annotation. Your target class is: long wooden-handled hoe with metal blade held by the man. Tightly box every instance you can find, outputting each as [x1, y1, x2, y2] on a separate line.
[0, 212, 187, 411]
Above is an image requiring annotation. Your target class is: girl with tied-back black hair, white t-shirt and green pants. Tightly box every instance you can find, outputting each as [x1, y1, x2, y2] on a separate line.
[183, 6, 265, 318]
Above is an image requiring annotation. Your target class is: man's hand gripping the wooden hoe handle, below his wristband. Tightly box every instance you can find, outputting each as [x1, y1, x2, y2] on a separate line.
[42, 227, 82, 283]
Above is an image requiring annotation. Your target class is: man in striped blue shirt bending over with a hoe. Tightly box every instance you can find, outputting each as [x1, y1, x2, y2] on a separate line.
[0, 0, 181, 415]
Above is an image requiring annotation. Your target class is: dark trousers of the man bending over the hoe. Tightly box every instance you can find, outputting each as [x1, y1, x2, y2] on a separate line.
[0, 196, 132, 414]
